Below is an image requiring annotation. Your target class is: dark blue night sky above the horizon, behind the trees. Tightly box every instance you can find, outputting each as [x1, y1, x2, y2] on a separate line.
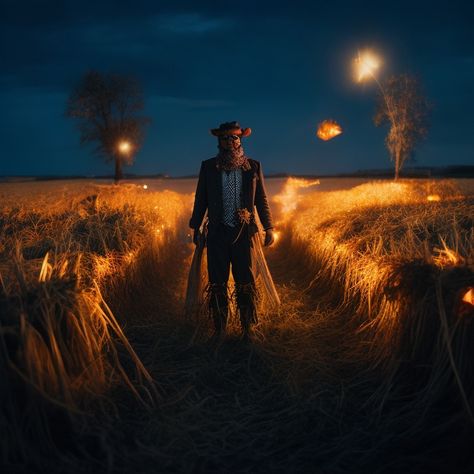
[0, 0, 474, 175]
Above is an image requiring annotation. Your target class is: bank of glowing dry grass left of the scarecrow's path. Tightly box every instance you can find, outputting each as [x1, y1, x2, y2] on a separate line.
[0, 183, 189, 464]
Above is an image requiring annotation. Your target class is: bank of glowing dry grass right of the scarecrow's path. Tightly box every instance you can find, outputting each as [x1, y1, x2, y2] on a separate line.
[282, 181, 474, 423]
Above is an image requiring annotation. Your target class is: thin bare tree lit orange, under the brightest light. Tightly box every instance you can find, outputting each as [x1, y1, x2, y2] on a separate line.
[374, 74, 431, 180]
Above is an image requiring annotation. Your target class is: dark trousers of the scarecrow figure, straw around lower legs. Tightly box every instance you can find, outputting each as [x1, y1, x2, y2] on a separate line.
[207, 224, 257, 330]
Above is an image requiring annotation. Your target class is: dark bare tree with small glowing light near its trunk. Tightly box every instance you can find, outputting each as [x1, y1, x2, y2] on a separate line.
[66, 71, 151, 183]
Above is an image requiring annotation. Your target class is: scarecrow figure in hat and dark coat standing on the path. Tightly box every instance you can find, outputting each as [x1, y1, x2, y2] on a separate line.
[187, 122, 279, 340]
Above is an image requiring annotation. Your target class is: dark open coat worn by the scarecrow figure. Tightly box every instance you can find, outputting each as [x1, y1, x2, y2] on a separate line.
[189, 158, 273, 237]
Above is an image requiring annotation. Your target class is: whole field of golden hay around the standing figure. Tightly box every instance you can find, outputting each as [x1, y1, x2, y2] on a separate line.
[0, 179, 474, 473]
